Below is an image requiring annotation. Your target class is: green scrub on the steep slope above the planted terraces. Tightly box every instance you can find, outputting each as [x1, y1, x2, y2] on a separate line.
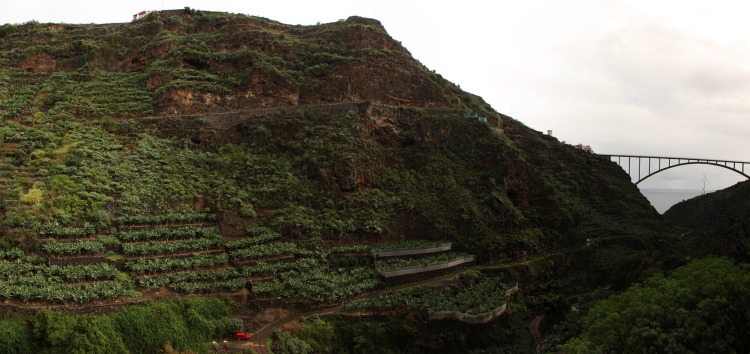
[0, 11, 668, 250]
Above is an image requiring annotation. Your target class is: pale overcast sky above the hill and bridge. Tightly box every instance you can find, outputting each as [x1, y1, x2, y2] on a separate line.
[0, 0, 750, 196]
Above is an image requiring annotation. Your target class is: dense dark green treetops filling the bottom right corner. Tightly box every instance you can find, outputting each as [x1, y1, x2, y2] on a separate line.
[562, 258, 750, 353]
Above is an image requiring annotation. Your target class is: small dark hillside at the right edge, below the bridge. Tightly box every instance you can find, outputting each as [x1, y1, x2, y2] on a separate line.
[664, 181, 750, 261]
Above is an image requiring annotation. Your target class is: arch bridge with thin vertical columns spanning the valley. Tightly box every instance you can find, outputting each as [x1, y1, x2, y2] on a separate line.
[600, 154, 750, 184]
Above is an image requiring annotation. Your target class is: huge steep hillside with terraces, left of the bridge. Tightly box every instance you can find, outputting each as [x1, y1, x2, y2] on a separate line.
[0, 9, 672, 350]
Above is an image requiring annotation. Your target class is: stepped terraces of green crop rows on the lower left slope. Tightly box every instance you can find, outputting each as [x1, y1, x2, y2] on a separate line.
[0, 201, 466, 304]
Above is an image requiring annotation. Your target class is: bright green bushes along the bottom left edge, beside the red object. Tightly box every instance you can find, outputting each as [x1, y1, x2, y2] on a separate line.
[0, 299, 242, 354]
